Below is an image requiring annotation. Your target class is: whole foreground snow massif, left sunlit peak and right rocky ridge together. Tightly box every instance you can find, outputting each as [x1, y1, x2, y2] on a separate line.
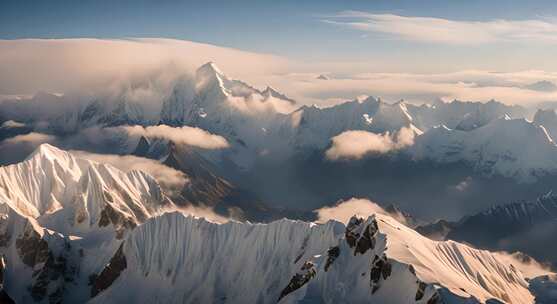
[0, 144, 552, 303]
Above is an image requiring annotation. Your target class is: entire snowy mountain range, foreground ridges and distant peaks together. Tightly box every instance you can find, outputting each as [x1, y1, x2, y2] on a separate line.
[0, 63, 557, 304]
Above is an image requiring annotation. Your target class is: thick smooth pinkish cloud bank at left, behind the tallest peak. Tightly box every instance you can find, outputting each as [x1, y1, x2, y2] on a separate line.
[0, 38, 288, 95]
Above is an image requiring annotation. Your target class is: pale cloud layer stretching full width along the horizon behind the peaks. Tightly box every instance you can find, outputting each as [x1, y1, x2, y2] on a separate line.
[5, 38, 557, 107]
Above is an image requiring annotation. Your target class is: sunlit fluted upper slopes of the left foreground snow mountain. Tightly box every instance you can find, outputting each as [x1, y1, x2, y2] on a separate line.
[0, 144, 173, 237]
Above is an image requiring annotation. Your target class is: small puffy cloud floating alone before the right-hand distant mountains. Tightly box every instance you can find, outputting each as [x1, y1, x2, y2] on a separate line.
[325, 128, 415, 160]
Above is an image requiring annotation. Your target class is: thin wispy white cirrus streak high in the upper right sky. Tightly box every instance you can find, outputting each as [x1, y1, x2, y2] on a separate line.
[322, 11, 557, 45]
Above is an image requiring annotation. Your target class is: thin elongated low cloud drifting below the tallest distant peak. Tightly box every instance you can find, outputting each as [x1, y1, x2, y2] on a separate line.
[116, 125, 229, 149]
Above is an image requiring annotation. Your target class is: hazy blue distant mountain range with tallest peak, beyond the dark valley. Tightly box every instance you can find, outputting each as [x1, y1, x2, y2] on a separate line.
[0, 63, 557, 219]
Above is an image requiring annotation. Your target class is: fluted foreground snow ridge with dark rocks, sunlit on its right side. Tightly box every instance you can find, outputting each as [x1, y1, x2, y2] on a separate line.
[92, 213, 533, 303]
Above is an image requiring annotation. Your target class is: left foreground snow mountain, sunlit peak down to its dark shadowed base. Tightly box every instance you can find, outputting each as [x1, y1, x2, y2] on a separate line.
[0, 144, 180, 303]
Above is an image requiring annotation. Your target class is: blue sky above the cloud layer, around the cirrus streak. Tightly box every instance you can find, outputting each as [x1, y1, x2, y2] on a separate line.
[0, 0, 557, 68]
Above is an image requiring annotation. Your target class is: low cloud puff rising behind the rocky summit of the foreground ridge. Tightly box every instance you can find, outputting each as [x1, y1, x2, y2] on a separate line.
[314, 198, 406, 224]
